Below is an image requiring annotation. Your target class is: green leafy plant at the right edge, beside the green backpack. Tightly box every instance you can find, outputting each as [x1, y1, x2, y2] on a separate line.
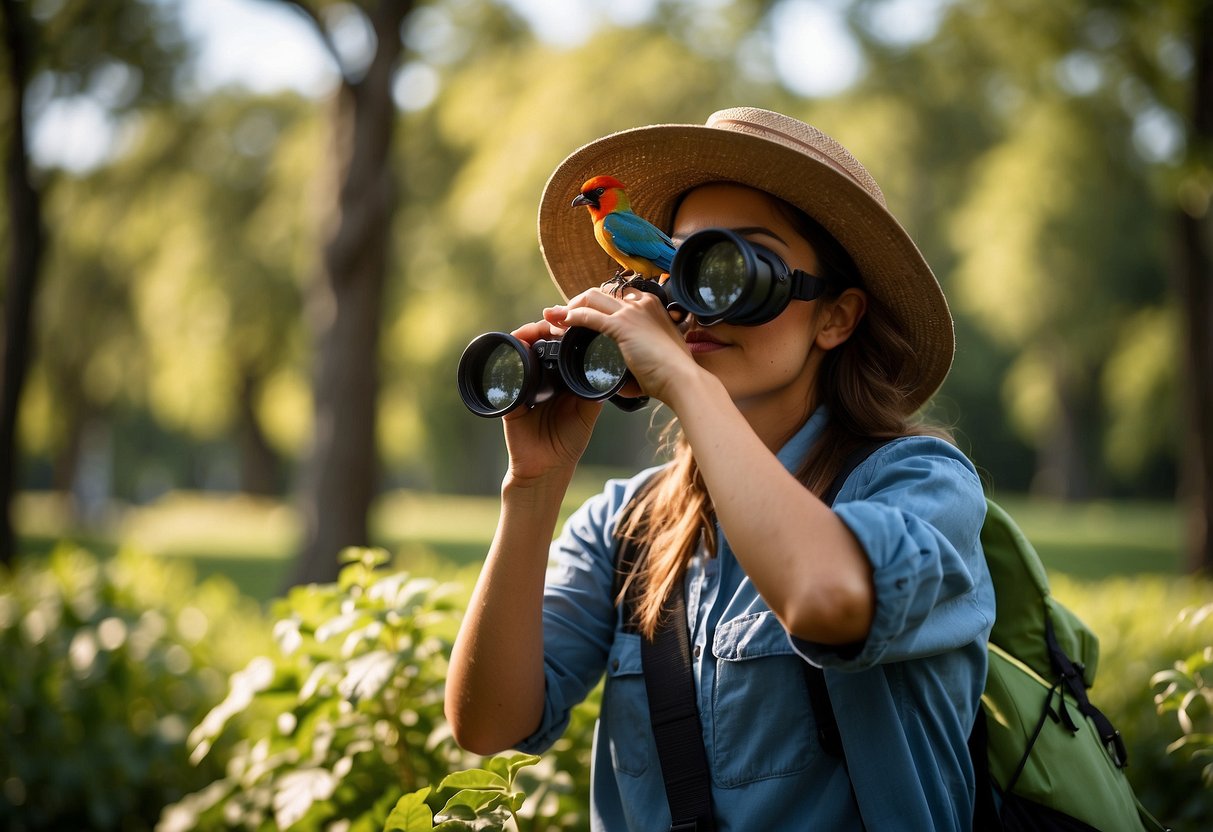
[1150, 604, 1213, 788]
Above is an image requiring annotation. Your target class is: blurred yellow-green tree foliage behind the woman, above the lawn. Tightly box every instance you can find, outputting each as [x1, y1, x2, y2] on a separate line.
[4, 0, 1213, 520]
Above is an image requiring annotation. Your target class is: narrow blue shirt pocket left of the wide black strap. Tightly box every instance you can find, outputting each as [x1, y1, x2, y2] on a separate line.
[602, 632, 656, 776]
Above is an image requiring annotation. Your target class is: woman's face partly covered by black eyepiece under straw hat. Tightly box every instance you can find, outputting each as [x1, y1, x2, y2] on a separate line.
[672, 183, 828, 429]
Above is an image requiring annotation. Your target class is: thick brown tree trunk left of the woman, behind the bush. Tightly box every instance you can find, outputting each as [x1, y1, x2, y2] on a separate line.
[290, 0, 412, 583]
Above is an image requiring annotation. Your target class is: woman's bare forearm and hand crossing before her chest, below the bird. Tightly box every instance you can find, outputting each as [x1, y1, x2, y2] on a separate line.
[555, 286, 876, 644]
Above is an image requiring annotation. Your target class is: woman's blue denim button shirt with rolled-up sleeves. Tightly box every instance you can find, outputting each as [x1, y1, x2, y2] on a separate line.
[519, 409, 995, 832]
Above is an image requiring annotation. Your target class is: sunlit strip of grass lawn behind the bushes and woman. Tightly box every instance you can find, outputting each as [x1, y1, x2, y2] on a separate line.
[15, 482, 1183, 602]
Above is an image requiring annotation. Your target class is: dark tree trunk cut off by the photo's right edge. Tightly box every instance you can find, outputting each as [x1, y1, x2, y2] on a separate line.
[1178, 4, 1213, 574]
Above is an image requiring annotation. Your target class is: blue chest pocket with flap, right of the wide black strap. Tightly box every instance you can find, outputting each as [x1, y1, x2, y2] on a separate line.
[712, 610, 820, 787]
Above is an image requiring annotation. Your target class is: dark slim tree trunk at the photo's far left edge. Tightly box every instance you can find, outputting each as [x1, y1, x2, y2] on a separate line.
[0, 0, 44, 564]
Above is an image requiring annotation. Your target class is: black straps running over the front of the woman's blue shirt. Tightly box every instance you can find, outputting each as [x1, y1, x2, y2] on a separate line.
[616, 439, 890, 832]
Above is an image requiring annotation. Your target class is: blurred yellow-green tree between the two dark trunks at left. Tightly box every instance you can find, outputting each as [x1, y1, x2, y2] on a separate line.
[103, 100, 318, 495]
